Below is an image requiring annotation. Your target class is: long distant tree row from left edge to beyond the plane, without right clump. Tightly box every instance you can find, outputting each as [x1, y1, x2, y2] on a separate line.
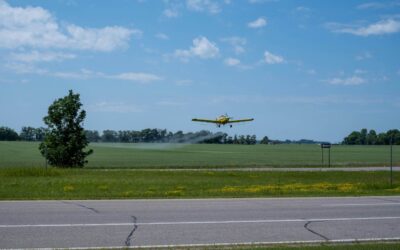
[0, 126, 260, 145]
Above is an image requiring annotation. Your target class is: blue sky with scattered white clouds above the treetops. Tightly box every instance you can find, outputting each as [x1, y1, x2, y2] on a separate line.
[0, 0, 400, 142]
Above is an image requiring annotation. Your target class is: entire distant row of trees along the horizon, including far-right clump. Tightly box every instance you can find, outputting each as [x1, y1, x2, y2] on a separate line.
[0, 127, 400, 145]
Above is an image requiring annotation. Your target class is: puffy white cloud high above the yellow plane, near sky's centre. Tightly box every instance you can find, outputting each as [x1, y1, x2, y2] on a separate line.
[174, 36, 219, 60]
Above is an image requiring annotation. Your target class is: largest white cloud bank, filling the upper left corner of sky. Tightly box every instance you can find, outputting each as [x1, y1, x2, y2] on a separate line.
[0, 0, 141, 51]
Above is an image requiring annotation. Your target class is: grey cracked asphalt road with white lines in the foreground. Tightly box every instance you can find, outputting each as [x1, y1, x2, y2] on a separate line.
[0, 196, 400, 248]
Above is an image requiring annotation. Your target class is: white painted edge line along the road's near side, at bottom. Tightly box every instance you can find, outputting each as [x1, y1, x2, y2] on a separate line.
[7, 237, 400, 250]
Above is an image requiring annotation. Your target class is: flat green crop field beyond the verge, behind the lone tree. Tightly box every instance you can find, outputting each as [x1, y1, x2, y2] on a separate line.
[0, 142, 400, 168]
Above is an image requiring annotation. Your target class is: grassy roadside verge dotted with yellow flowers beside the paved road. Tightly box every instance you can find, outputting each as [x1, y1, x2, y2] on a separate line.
[0, 168, 400, 200]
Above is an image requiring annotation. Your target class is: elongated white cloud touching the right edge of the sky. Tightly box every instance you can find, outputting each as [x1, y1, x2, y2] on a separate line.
[327, 19, 400, 36]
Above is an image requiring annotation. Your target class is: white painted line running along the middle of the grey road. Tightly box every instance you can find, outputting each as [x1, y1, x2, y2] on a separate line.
[0, 216, 400, 228]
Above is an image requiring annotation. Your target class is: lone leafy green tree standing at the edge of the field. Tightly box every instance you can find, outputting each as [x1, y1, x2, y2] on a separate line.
[39, 90, 93, 168]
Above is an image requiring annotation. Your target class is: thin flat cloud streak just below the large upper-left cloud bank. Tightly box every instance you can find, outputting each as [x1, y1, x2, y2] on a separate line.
[10, 50, 76, 63]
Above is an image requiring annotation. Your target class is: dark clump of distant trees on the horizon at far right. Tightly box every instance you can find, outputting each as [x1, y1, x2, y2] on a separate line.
[342, 128, 400, 145]
